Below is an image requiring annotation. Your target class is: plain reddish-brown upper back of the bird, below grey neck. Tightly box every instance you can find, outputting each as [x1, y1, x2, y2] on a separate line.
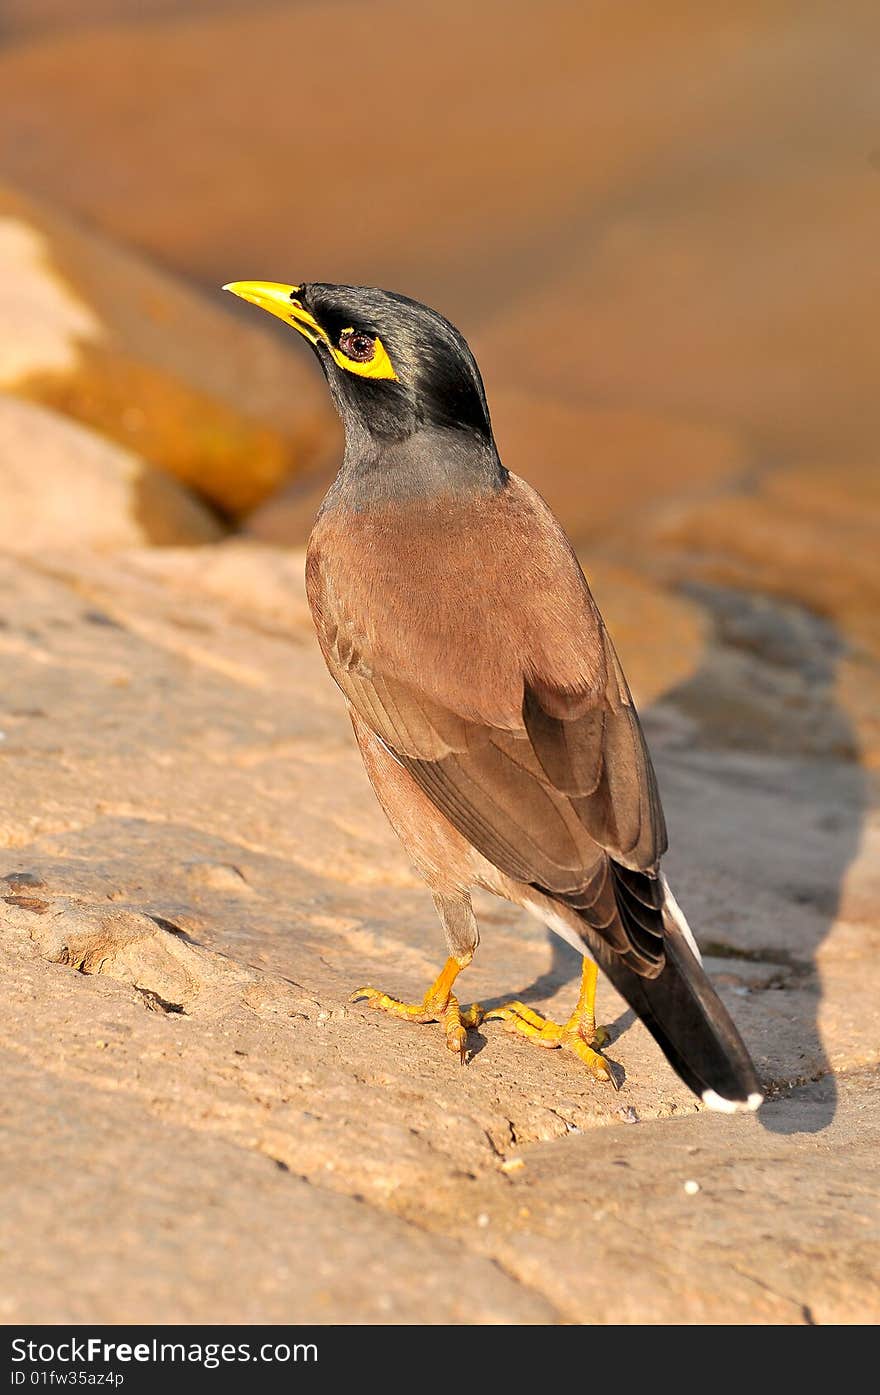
[307, 476, 604, 725]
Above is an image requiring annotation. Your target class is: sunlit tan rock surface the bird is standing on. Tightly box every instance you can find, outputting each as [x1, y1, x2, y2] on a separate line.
[0, 543, 880, 1322]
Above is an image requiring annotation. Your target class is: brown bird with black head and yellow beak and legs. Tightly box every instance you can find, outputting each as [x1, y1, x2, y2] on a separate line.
[223, 280, 763, 1113]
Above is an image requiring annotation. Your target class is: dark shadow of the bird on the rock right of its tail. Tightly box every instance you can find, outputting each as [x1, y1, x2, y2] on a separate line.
[646, 585, 866, 1133]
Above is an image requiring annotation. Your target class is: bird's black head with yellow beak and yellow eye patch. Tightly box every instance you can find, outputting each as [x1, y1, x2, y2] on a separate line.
[223, 280, 492, 442]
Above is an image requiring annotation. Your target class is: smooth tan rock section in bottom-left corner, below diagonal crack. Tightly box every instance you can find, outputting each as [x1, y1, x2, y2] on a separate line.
[0, 1060, 556, 1322]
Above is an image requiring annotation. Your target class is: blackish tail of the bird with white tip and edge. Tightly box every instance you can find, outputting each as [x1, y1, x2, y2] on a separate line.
[546, 877, 764, 1113]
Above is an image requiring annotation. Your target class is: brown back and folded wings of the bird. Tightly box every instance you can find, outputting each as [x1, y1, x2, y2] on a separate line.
[307, 477, 665, 974]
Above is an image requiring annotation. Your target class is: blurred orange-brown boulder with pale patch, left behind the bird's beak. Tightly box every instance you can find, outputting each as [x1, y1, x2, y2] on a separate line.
[0, 186, 329, 516]
